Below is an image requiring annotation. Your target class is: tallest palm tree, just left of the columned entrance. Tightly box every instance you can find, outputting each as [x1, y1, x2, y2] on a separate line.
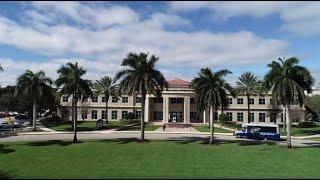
[114, 53, 168, 142]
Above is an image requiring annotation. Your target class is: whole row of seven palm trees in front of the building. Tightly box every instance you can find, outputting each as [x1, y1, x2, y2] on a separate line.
[0, 52, 314, 148]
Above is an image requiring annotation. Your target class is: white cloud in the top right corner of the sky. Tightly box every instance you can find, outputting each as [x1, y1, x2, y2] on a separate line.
[169, 1, 320, 36]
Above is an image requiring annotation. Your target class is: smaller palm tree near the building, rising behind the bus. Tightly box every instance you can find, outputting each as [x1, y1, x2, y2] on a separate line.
[236, 72, 262, 123]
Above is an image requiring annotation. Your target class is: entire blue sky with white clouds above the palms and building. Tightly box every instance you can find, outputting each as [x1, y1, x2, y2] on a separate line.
[0, 1, 320, 87]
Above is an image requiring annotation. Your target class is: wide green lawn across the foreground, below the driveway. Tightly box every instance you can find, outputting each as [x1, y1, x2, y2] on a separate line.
[0, 139, 320, 178]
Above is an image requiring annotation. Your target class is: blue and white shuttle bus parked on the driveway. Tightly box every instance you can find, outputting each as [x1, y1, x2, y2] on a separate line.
[234, 123, 280, 141]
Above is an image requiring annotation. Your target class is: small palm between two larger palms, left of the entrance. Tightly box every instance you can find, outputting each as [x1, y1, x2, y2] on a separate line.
[93, 76, 118, 124]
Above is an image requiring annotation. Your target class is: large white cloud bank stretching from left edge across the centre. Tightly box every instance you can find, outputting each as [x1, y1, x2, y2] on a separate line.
[0, 2, 289, 84]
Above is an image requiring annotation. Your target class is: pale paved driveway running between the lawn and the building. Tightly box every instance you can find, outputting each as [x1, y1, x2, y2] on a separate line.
[0, 131, 320, 147]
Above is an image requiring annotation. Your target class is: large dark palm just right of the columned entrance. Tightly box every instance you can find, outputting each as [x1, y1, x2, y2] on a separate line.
[191, 68, 231, 144]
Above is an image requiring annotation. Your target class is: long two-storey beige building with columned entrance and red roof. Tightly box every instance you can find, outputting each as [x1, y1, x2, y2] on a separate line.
[59, 79, 306, 124]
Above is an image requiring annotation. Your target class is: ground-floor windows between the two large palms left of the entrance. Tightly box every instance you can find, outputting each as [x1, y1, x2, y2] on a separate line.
[81, 110, 141, 120]
